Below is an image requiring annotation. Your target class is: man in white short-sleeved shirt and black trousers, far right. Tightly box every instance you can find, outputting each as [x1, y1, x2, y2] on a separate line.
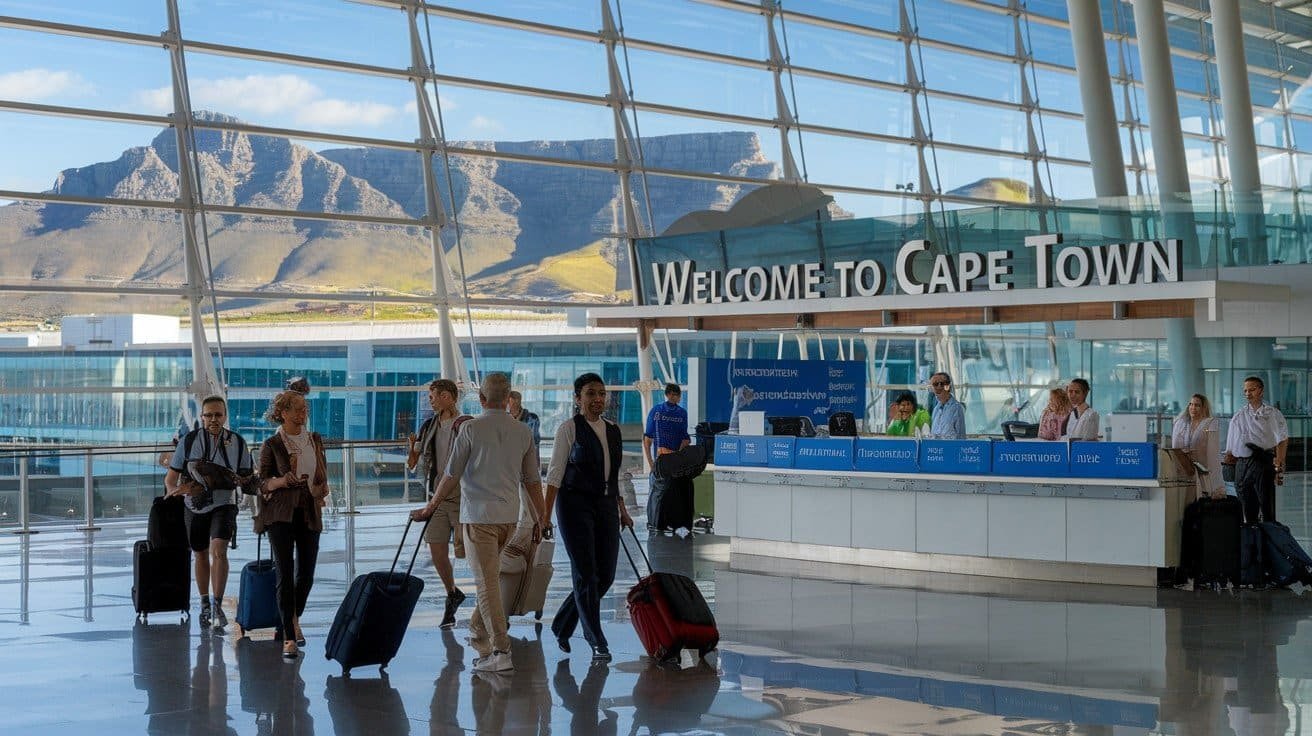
[1221, 375, 1290, 522]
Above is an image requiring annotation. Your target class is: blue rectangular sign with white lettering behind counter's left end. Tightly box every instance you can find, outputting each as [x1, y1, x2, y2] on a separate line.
[705, 358, 866, 426]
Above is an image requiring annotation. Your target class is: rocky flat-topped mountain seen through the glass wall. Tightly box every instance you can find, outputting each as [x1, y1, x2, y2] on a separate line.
[0, 114, 778, 312]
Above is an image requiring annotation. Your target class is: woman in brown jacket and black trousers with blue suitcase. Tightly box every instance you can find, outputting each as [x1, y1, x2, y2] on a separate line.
[256, 391, 328, 660]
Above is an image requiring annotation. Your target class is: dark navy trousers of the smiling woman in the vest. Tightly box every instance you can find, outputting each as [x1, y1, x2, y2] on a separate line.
[551, 489, 619, 647]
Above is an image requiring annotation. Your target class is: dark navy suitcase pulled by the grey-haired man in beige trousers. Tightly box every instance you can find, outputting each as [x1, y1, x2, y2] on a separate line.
[324, 518, 428, 676]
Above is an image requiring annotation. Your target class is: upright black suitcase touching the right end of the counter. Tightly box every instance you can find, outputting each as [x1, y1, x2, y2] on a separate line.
[1181, 496, 1244, 586]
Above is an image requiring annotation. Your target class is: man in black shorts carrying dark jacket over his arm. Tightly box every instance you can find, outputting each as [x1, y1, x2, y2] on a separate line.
[164, 396, 255, 631]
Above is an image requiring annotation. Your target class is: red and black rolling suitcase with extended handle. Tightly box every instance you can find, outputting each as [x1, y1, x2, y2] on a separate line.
[619, 527, 720, 661]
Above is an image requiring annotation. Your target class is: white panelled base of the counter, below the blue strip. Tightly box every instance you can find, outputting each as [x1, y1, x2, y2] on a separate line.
[715, 467, 1193, 585]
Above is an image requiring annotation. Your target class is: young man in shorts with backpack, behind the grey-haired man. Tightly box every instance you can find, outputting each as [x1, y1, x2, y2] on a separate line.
[405, 378, 474, 628]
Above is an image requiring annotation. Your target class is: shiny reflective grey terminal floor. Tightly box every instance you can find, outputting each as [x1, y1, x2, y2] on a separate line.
[0, 478, 1312, 736]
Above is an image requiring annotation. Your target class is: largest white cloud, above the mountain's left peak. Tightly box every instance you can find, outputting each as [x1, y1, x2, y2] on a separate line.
[135, 75, 413, 127]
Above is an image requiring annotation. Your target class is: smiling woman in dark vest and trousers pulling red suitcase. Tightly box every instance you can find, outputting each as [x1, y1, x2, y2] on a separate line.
[546, 373, 634, 661]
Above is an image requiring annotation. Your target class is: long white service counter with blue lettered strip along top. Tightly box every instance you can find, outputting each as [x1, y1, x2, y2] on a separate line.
[714, 434, 1194, 585]
